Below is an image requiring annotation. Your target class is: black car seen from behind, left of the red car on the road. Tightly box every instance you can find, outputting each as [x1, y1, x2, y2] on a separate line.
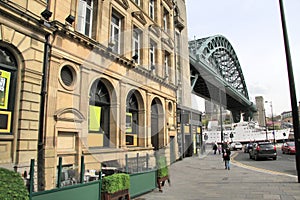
[249, 142, 277, 160]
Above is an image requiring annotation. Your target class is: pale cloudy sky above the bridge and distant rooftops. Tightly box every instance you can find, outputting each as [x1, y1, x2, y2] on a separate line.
[186, 0, 300, 116]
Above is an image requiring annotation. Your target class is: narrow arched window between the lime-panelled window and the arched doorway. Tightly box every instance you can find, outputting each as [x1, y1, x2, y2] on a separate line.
[126, 92, 139, 146]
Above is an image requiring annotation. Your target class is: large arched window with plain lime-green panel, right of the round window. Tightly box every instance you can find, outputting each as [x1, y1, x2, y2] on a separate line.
[88, 79, 110, 147]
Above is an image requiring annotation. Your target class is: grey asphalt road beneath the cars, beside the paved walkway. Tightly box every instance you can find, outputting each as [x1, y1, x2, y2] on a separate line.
[234, 149, 297, 176]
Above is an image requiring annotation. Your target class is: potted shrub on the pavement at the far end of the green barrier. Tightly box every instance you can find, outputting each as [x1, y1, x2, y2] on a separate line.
[157, 156, 170, 192]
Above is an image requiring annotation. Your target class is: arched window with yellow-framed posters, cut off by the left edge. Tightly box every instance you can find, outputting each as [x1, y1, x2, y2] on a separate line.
[0, 47, 17, 134]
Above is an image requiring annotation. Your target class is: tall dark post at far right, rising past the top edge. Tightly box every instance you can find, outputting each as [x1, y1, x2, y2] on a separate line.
[279, 0, 300, 183]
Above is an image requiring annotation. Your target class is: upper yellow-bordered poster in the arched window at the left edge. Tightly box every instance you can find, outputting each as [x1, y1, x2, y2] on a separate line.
[0, 70, 10, 109]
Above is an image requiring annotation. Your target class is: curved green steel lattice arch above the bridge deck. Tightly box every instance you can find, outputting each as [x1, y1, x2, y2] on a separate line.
[190, 35, 249, 99]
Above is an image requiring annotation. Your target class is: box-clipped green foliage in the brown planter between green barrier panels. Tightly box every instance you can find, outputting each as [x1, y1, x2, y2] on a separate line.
[102, 173, 130, 194]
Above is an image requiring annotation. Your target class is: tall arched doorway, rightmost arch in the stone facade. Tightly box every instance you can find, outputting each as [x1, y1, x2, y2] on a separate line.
[151, 98, 164, 151]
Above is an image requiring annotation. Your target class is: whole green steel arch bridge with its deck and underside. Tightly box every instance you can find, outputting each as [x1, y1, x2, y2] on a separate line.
[189, 35, 256, 122]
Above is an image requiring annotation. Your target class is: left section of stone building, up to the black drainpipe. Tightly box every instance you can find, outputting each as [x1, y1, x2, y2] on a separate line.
[0, 0, 54, 183]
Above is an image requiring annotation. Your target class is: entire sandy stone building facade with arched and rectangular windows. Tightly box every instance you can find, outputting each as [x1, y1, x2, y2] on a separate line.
[0, 0, 191, 190]
